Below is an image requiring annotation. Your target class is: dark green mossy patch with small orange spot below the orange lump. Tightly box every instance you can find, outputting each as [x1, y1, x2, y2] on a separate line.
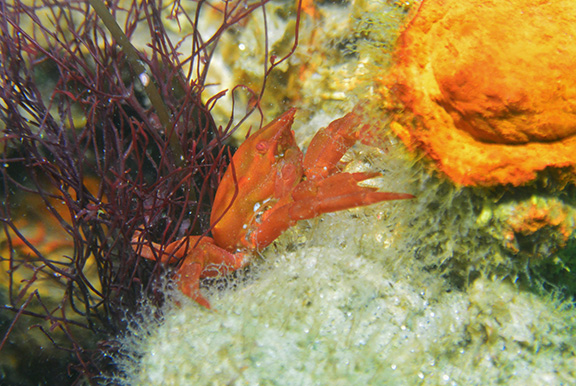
[392, 143, 576, 297]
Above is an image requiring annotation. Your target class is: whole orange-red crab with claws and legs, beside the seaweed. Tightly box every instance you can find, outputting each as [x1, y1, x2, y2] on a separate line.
[133, 109, 413, 308]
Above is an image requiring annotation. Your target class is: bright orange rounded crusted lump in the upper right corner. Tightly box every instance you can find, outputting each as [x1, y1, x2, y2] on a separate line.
[381, 0, 576, 186]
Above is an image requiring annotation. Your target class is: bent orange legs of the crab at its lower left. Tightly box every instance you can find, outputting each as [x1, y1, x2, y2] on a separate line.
[132, 232, 247, 308]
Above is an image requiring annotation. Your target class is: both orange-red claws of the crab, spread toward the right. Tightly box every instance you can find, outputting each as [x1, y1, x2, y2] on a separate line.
[250, 112, 414, 248]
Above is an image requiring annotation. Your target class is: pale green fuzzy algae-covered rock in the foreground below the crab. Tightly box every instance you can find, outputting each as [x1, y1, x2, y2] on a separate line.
[112, 243, 576, 385]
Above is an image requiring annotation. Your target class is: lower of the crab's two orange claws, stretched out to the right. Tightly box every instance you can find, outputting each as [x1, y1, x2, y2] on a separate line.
[250, 173, 414, 248]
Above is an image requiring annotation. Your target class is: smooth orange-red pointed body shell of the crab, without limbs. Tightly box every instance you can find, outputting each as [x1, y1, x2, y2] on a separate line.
[210, 109, 303, 251]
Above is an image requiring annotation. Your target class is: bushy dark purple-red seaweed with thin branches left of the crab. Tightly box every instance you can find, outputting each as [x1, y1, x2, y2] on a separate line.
[0, 0, 298, 384]
